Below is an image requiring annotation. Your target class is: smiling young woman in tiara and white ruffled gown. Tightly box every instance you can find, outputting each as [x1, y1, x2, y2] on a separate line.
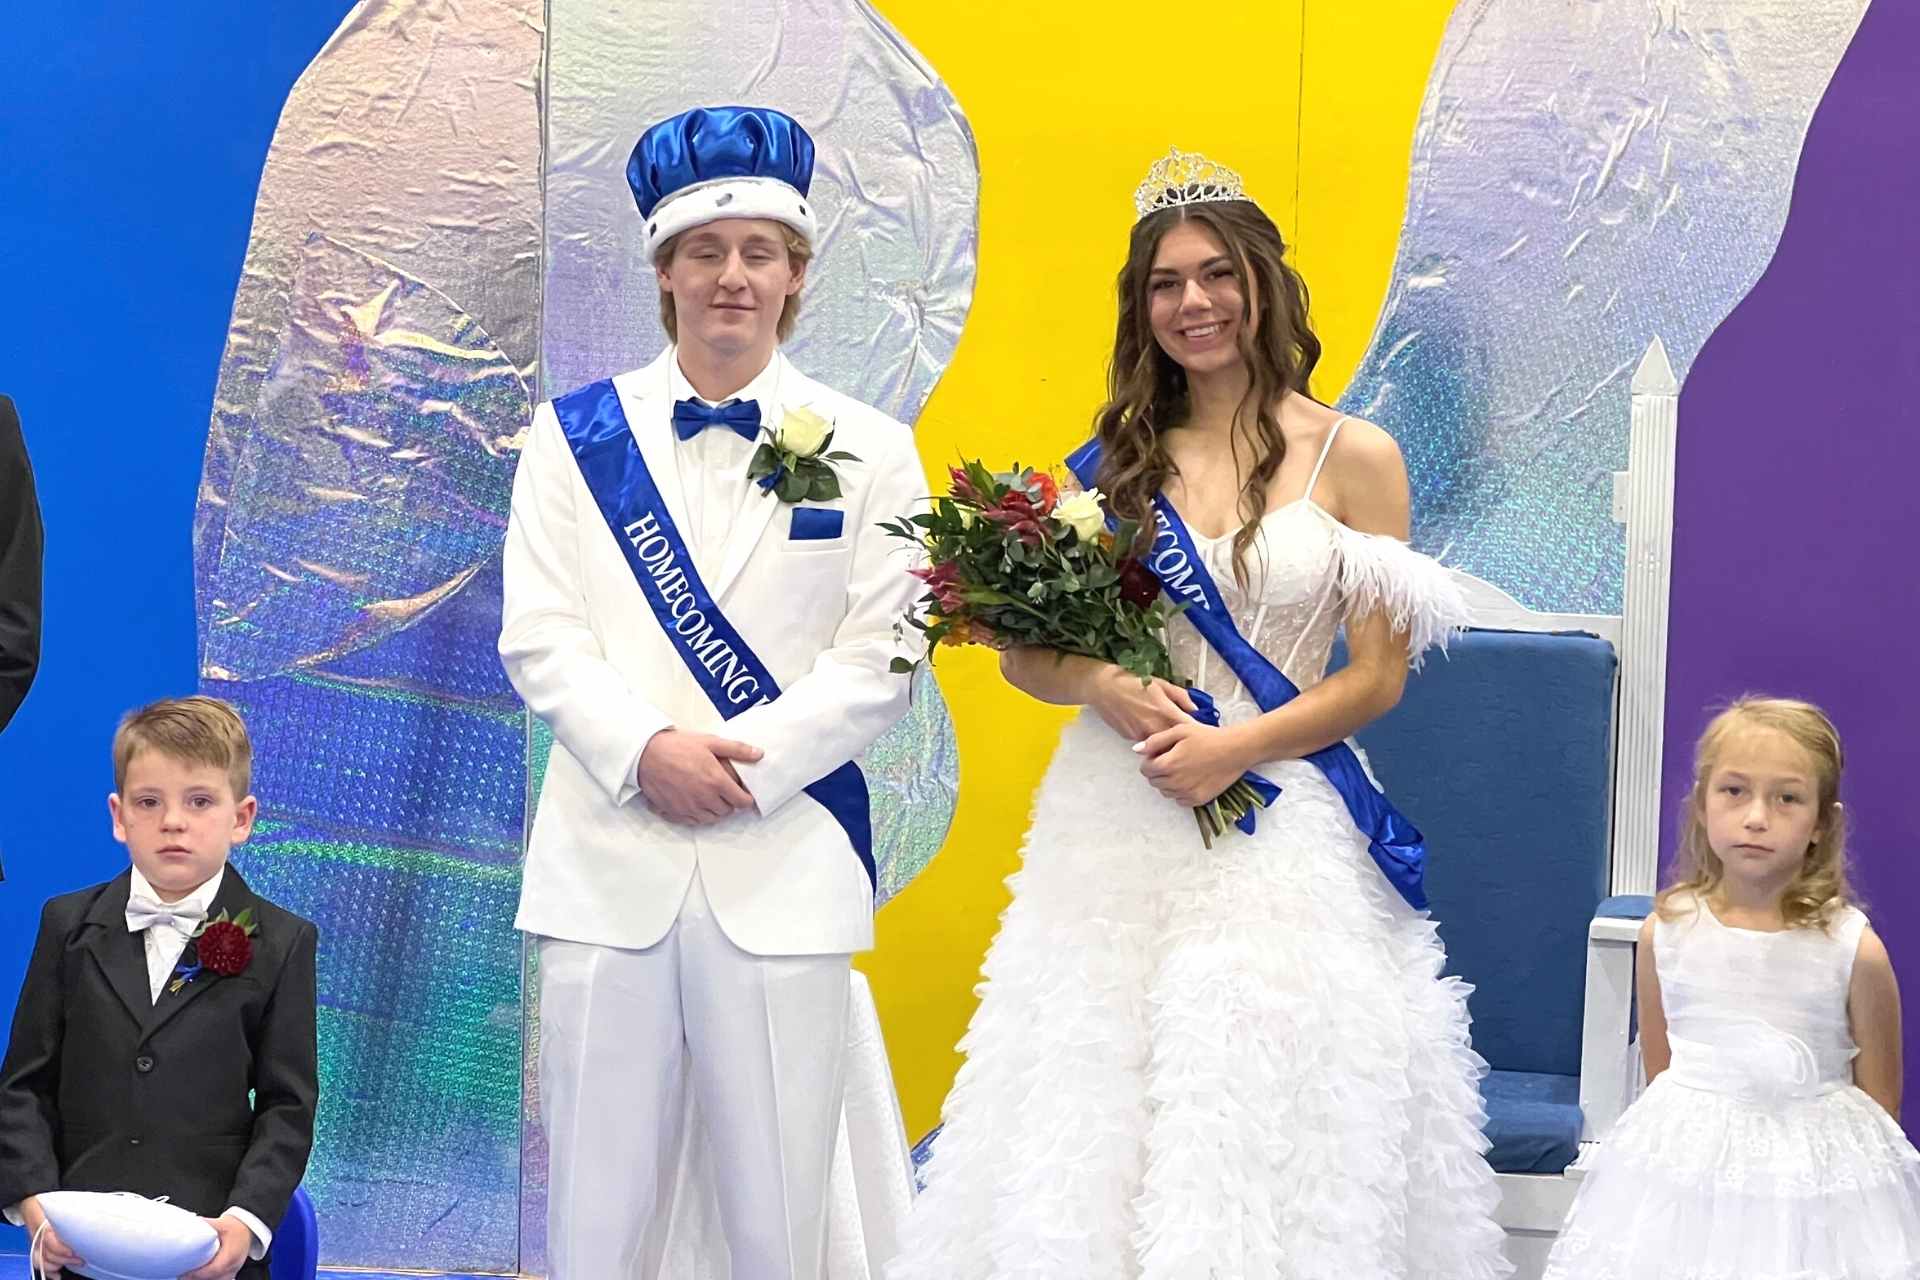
[887, 154, 1509, 1280]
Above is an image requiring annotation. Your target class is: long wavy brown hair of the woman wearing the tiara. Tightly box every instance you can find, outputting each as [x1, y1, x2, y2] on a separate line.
[1092, 200, 1321, 583]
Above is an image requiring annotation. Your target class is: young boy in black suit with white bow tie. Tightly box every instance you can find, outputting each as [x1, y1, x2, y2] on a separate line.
[0, 697, 319, 1280]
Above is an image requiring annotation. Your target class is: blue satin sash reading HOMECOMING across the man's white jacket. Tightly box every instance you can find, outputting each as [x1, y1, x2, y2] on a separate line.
[553, 380, 876, 885]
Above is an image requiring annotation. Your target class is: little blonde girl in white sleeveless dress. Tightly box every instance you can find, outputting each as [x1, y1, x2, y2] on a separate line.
[1546, 699, 1920, 1280]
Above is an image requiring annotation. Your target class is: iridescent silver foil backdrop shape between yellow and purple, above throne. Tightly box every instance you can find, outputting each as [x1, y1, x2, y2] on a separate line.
[1340, 0, 1866, 614]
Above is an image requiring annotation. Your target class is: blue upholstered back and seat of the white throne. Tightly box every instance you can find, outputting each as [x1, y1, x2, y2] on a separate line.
[1336, 631, 1617, 1173]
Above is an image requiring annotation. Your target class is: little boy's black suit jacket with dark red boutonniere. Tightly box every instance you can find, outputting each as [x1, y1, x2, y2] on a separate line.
[0, 865, 319, 1276]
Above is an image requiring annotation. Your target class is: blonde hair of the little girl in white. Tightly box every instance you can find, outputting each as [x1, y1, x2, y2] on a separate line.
[1655, 693, 1859, 929]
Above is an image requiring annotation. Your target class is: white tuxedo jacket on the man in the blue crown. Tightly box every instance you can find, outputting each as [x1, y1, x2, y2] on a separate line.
[499, 347, 925, 956]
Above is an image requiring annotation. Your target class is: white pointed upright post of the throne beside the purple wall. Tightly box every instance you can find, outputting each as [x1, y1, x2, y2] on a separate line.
[1613, 336, 1680, 894]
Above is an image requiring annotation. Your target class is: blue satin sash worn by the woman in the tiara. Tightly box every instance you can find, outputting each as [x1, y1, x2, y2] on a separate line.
[1068, 439, 1427, 912]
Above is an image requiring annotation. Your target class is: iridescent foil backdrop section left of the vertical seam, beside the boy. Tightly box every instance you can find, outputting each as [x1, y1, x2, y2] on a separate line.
[196, 0, 543, 1270]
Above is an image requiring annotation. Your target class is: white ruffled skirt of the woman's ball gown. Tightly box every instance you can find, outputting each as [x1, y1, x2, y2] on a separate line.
[887, 712, 1509, 1280]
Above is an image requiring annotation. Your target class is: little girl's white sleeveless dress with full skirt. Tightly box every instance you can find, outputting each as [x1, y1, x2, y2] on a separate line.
[1546, 898, 1920, 1280]
